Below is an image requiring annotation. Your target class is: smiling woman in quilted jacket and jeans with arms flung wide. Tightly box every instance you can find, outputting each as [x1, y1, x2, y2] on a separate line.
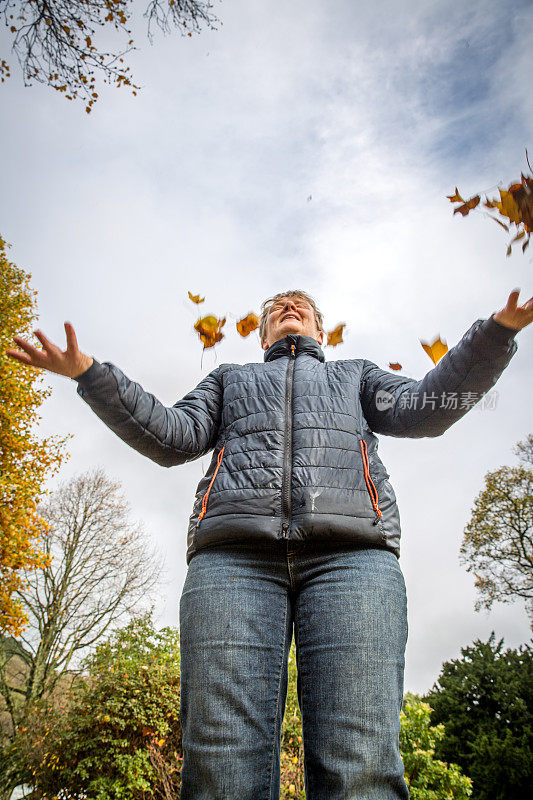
[7, 290, 533, 800]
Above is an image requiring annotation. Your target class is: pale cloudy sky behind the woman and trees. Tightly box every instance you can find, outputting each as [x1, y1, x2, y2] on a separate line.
[0, 0, 533, 692]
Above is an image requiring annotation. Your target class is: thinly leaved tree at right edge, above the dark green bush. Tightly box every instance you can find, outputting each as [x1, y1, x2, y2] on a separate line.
[459, 434, 533, 629]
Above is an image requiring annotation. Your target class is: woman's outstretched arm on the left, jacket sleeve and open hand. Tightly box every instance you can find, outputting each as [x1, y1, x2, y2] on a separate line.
[6, 323, 222, 467]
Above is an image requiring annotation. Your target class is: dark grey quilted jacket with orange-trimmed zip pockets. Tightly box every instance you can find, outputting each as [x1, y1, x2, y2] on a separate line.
[75, 315, 517, 564]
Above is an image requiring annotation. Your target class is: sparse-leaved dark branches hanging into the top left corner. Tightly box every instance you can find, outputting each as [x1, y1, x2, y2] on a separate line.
[0, 0, 217, 113]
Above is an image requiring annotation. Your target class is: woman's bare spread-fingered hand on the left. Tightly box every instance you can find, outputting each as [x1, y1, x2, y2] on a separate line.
[6, 322, 93, 378]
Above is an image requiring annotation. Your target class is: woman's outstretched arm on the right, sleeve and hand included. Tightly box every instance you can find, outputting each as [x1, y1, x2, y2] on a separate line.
[361, 290, 533, 438]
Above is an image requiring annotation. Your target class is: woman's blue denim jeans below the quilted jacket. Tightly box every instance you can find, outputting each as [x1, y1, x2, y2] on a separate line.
[180, 541, 409, 800]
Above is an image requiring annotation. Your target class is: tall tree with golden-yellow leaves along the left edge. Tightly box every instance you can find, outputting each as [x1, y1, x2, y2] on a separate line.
[0, 236, 70, 636]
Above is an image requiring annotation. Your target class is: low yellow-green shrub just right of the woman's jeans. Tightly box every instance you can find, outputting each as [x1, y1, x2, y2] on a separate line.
[400, 692, 472, 800]
